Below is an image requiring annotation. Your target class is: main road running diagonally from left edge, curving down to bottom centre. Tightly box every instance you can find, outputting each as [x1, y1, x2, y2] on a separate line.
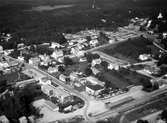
[4, 56, 94, 123]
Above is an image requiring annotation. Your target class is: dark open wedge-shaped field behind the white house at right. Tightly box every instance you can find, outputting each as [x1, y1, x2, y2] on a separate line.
[102, 37, 152, 63]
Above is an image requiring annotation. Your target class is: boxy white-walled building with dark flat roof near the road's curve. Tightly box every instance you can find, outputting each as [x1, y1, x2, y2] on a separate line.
[86, 84, 103, 96]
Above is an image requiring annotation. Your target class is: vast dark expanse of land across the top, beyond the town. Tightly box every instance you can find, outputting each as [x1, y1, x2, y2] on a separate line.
[0, 0, 167, 44]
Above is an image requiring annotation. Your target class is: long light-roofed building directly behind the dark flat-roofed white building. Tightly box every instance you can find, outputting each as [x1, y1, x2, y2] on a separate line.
[86, 76, 104, 86]
